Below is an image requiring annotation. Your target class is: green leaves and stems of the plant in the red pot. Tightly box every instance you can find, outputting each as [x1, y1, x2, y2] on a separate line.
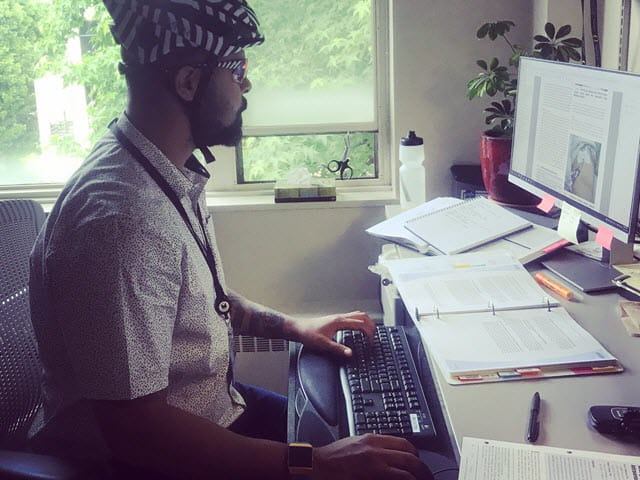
[467, 20, 582, 137]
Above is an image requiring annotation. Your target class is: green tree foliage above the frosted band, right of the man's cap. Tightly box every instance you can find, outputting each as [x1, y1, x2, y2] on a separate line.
[249, 0, 373, 88]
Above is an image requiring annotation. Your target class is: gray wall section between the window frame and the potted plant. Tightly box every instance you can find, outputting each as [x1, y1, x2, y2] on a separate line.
[392, 0, 533, 201]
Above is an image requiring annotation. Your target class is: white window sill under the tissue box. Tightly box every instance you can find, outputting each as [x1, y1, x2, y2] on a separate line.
[207, 189, 398, 211]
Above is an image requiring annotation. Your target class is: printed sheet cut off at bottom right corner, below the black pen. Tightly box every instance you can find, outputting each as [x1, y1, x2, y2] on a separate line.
[458, 437, 640, 480]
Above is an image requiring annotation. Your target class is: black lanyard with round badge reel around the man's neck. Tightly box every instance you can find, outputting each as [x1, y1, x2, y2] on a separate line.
[110, 123, 231, 322]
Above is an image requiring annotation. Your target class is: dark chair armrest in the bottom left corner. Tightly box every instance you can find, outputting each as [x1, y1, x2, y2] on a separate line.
[0, 450, 97, 480]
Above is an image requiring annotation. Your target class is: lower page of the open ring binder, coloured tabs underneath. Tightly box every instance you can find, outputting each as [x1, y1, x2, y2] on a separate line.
[418, 307, 618, 383]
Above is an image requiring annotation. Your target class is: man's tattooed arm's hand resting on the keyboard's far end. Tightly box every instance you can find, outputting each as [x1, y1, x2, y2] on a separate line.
[288, 312, 375, 357]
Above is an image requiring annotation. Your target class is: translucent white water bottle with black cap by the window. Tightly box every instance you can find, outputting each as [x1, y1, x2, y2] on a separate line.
[400, 130, 427, 209]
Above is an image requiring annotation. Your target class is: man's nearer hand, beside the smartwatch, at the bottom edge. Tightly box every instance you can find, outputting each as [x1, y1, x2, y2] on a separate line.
[312, 434, 433, 480]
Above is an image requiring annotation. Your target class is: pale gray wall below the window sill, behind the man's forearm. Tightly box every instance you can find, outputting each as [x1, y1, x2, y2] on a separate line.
[213, 205, 384, 312]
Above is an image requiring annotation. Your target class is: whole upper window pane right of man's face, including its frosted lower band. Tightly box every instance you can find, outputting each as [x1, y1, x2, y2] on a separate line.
[243, 0, 377, 136]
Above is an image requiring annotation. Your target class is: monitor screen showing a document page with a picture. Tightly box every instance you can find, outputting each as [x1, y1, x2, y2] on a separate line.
[509, 57, 640, 243]
